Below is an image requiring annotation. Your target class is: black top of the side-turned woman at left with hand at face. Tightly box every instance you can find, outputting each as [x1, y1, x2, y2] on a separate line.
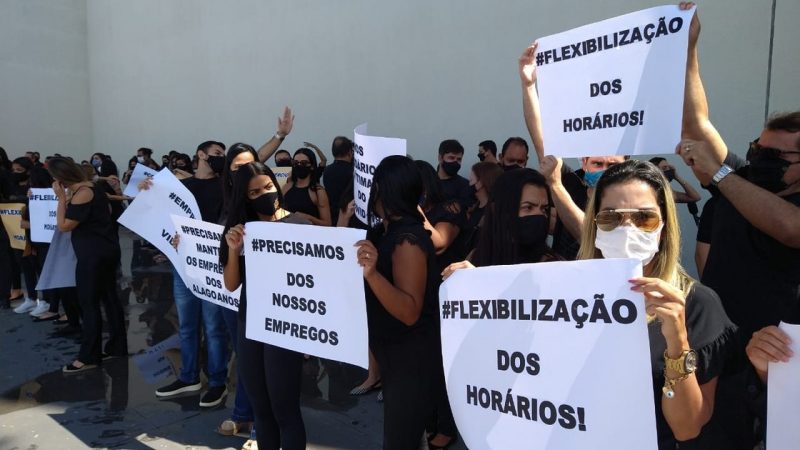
[64, 186, 119, 261]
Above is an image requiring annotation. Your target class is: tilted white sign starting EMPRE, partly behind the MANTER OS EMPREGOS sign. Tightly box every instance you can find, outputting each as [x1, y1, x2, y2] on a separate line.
[117, 170, 200, 277]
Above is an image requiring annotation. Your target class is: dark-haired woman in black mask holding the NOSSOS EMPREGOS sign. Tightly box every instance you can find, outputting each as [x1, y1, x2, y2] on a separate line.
[219, 162, 308, 450]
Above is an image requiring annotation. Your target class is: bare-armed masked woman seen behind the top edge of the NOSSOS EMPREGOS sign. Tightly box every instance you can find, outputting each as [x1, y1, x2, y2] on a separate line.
[283, 148, 331, 226]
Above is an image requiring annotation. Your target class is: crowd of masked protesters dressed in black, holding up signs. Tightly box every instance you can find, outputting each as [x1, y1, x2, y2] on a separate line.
[0, 3, 800, 450]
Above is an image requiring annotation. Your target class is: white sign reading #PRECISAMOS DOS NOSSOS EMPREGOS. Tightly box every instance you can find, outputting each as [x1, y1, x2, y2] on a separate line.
[244, 222, 369, 368]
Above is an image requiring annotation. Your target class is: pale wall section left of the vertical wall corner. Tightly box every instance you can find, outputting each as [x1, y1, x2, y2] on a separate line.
[0, 0, 92, 158]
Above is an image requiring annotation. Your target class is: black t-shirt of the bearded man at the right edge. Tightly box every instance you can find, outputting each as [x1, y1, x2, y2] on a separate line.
[702, 155, 800, 336]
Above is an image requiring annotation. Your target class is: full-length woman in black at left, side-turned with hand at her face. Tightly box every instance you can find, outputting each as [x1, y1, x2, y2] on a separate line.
[48, 158, 128, 373]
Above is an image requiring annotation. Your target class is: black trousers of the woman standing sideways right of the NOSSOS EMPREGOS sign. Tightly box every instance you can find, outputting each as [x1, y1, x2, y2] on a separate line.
[370, 330, 437, 450]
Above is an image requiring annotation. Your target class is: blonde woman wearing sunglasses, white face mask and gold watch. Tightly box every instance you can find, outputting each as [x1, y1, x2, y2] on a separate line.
[578, 160, 735, 449]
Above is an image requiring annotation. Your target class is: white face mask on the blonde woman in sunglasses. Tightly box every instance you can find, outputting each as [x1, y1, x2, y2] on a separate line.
[594, 223, 664, 266]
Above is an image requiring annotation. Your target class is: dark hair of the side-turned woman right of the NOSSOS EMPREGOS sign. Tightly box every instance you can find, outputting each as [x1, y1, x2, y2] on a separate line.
[367, 155, 424, 224]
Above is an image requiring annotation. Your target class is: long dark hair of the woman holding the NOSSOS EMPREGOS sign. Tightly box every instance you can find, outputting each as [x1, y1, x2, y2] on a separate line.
[219, 161, 283, 266]
